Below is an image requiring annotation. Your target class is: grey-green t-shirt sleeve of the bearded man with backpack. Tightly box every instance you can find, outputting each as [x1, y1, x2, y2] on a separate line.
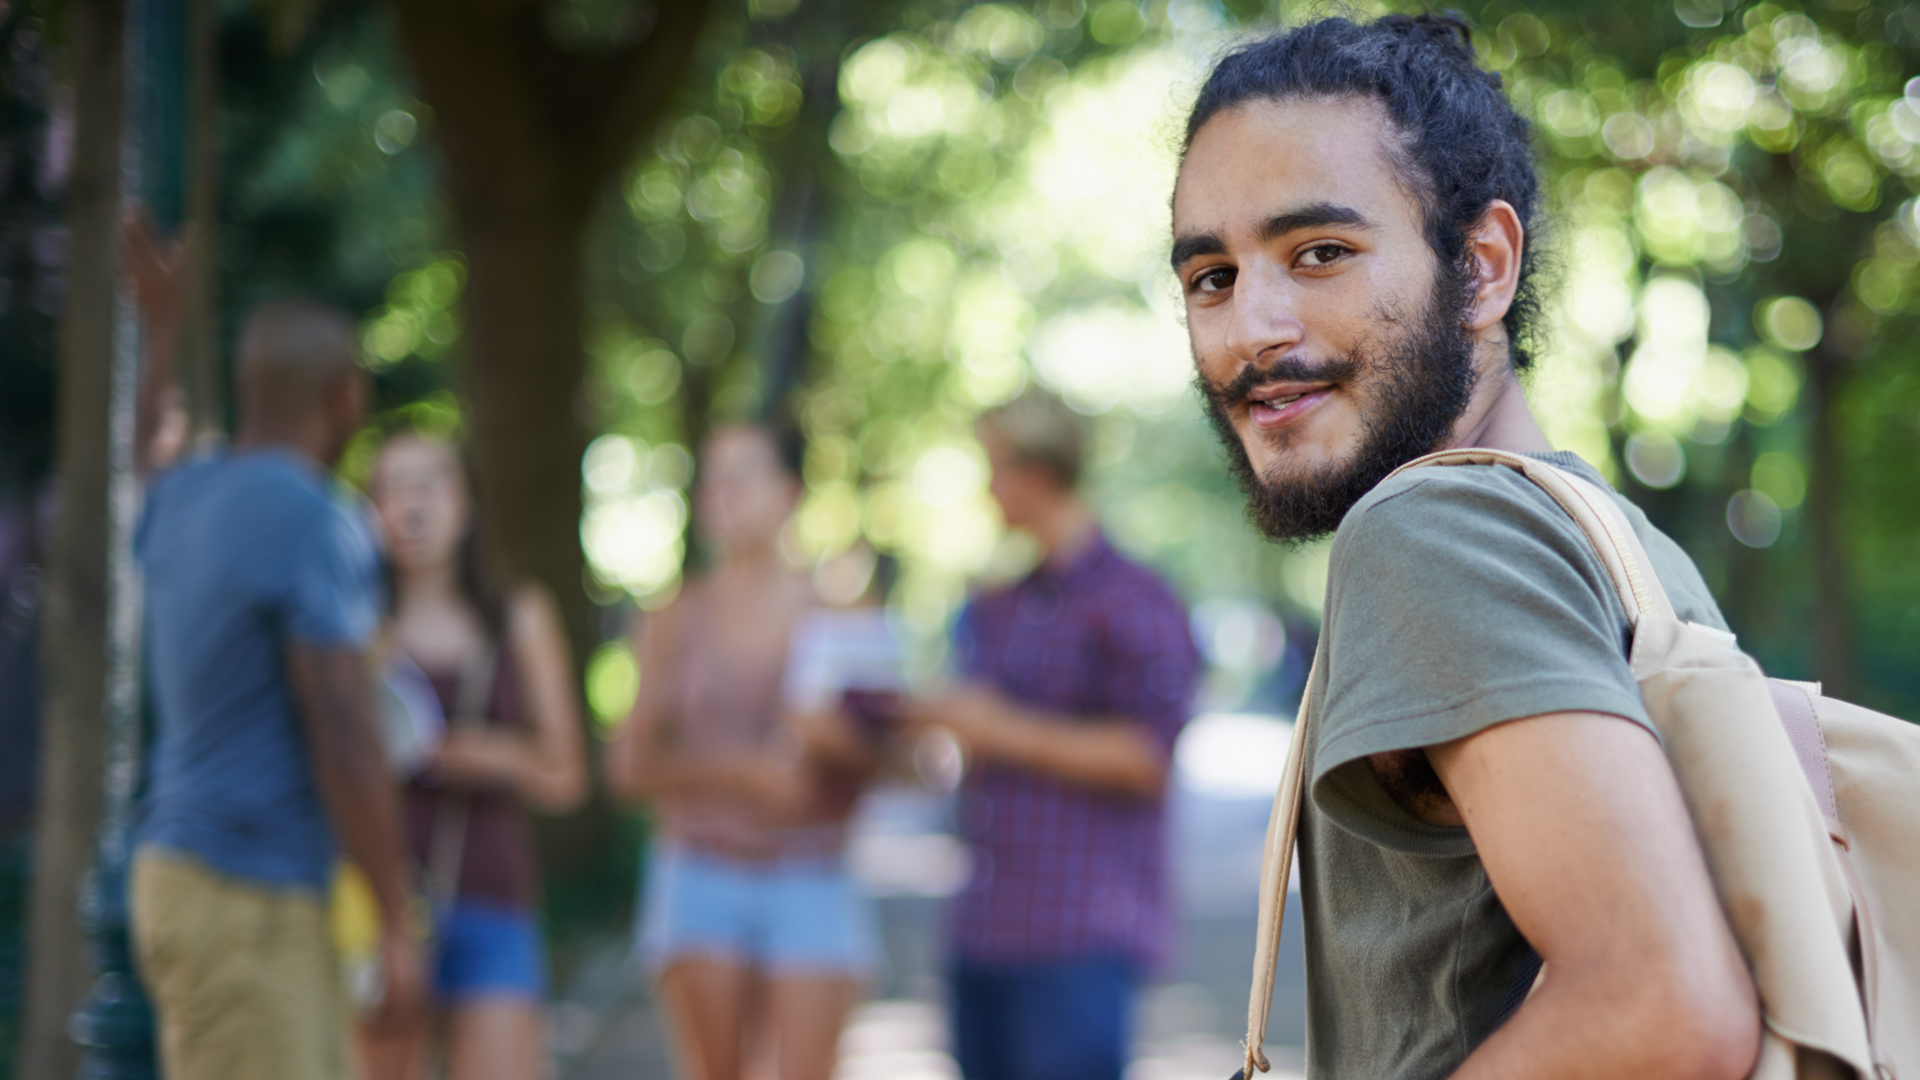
[1311, 467, 1651, 847]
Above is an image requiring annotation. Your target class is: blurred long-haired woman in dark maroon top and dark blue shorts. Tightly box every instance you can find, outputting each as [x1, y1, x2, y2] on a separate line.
[361, 432, 588, 1080]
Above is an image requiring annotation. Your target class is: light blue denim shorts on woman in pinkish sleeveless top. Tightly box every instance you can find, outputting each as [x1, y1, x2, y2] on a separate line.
[636, 844, 879, 978]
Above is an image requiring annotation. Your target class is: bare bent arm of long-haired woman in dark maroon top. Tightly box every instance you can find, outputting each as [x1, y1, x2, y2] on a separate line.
[432, 586, 588, 813]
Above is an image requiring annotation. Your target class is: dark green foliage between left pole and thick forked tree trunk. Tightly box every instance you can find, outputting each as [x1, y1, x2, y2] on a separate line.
[217, 0, 451, 424]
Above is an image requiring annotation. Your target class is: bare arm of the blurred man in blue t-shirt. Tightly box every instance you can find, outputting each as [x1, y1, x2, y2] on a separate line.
[286, 640, 424, 1011]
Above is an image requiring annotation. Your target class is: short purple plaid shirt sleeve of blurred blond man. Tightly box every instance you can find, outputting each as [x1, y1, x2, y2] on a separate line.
[1102, 582, 1200, 755]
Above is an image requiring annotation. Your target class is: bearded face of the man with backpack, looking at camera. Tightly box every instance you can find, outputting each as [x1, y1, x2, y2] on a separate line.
[1173, 98, 1475, 538]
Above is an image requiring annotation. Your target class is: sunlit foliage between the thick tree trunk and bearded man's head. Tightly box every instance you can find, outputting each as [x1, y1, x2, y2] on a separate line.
[586, 2, 1273, 638]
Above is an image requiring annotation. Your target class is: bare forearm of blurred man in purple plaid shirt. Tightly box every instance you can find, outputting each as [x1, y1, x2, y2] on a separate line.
[908, 688, 1167, 799]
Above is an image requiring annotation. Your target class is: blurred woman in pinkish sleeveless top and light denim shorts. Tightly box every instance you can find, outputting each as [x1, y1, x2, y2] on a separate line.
[605, 427, 877, 1080]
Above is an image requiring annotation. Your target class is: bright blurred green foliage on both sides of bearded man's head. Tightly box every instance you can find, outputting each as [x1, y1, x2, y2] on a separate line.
[586, 0, 1920, 709]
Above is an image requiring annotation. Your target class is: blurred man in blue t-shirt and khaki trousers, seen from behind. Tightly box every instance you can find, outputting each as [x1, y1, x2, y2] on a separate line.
[132, 300, 420, 1080]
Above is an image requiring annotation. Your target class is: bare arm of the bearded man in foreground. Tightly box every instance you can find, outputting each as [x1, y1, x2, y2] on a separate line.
[1428, 713, 1761, 1080]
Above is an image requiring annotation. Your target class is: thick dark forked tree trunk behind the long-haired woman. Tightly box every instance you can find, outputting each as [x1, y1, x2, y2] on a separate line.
[392, 0, 707, 874]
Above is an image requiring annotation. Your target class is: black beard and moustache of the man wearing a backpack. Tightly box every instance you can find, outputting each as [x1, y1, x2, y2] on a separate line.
[1194, 273, 1476, 542]
